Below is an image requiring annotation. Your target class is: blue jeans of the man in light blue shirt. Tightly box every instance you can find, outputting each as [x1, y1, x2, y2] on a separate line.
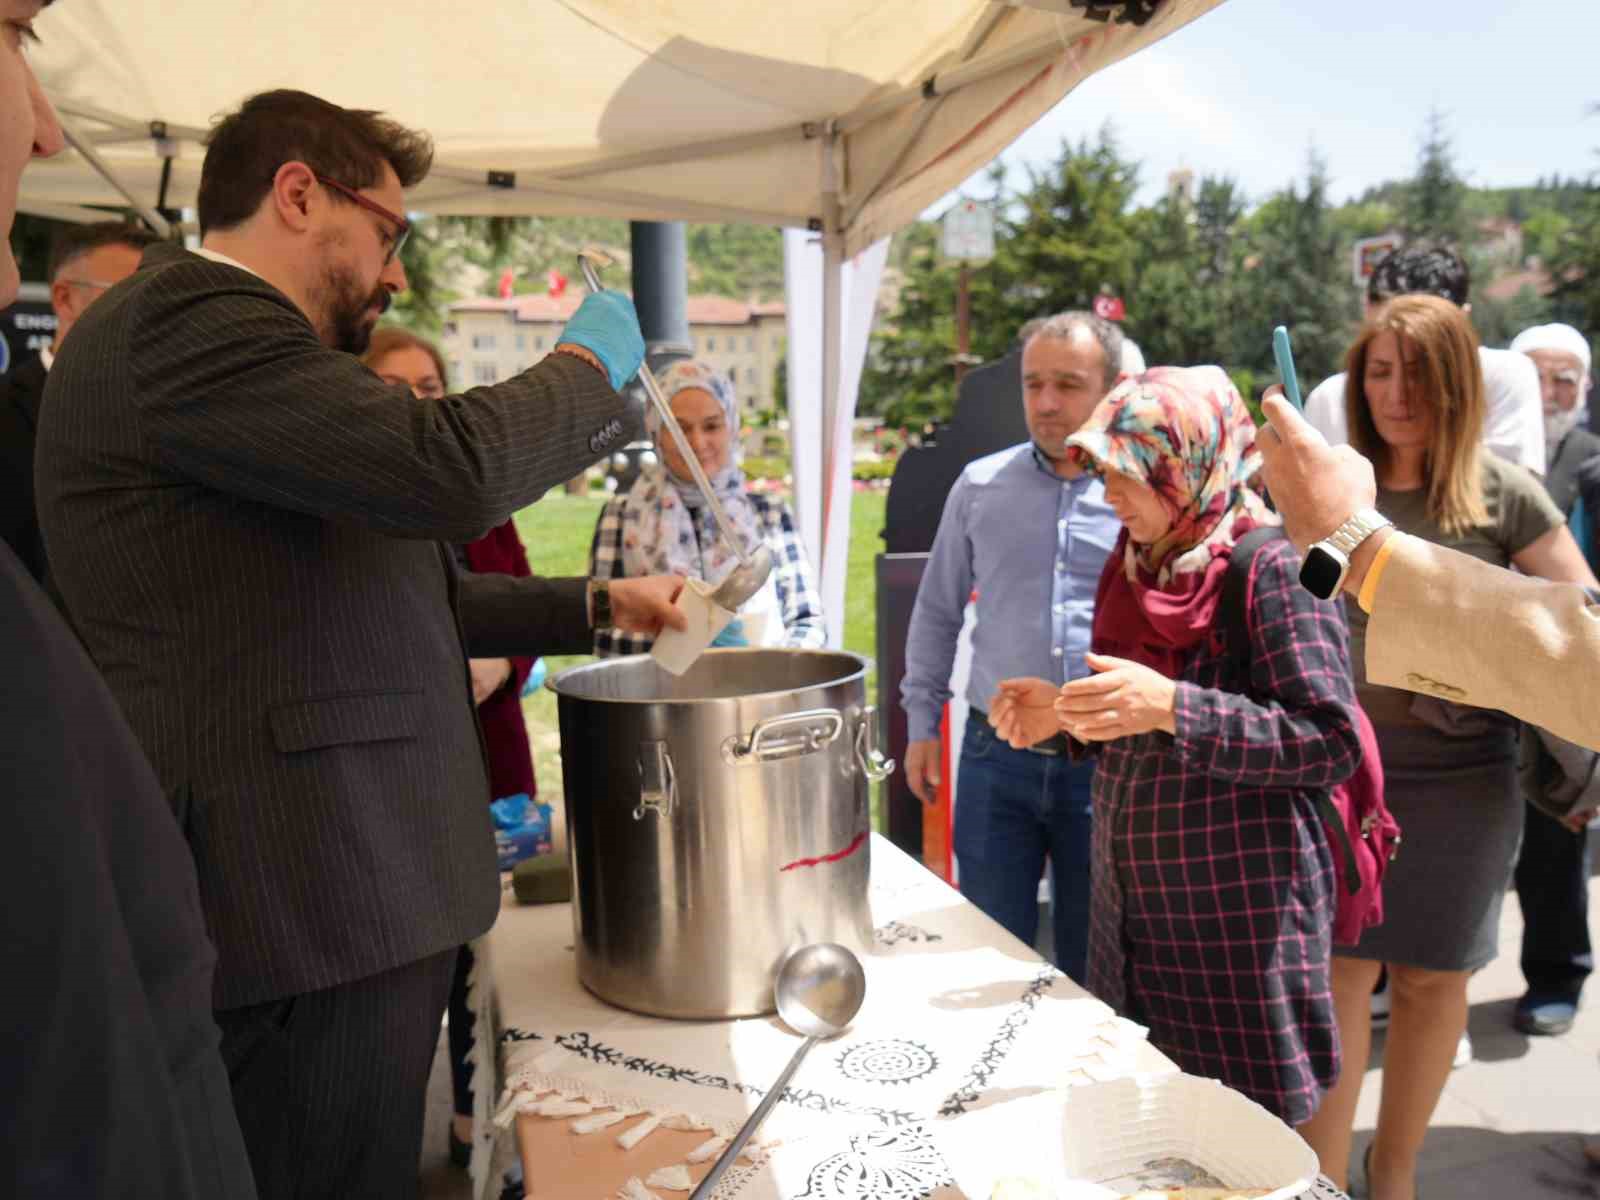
[955, 717, 1094, 984]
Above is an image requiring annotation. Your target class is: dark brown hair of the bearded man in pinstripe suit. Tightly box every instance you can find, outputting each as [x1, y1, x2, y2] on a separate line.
[198, 88, 434, 235]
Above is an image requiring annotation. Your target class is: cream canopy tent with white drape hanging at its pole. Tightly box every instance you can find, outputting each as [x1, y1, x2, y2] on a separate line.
[19, 0, 1221, 642]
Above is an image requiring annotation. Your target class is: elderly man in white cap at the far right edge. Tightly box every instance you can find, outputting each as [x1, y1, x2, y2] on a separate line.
[1510, 325, 1600, 1037]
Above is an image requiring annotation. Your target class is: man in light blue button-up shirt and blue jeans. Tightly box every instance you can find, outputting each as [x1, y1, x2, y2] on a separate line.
[901, 312, 1122, 982]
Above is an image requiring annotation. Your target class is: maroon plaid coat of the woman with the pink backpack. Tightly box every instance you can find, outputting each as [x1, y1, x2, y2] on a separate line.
[1090, 541, 1360, 1125]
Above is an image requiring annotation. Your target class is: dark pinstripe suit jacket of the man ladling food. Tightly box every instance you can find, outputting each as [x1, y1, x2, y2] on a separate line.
[35, 246, 634, 1008]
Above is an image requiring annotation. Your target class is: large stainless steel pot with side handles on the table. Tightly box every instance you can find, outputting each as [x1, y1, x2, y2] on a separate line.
[546, 650, 893, 1018]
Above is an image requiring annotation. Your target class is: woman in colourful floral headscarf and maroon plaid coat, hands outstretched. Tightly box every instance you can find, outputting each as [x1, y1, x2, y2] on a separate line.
[990, 366, 1360, 1125]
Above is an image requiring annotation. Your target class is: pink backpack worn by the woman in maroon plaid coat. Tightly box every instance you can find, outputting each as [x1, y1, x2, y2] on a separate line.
[1218, 525, 1400, 946]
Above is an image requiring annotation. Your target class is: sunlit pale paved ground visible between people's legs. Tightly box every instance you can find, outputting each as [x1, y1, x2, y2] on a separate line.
[422, 857, 1600, 1200]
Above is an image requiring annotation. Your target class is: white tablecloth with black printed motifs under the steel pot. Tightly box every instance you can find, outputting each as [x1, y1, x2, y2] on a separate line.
[474, 835, 1350, 1200]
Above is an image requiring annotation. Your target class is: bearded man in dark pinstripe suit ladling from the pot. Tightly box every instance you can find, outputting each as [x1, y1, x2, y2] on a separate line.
[37, 91, 680, 1197]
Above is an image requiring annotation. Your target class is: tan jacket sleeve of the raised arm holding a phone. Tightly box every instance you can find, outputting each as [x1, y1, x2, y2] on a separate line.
[1366, 534, 1600, 749]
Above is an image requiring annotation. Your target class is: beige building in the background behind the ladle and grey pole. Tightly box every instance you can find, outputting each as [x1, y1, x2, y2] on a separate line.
[442, 293, 786, 411]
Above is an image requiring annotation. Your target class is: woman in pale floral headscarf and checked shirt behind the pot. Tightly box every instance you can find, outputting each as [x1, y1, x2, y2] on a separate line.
[589, 360, 827, 658]
